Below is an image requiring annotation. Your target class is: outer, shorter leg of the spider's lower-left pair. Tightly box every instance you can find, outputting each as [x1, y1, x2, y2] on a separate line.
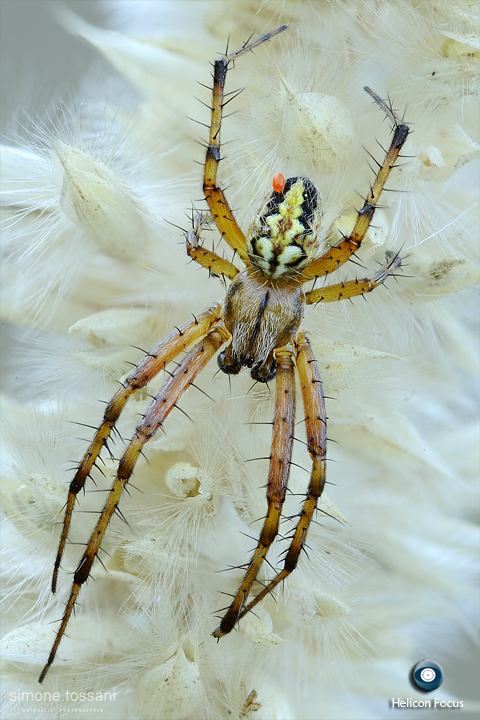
[52, 303, 221, 593]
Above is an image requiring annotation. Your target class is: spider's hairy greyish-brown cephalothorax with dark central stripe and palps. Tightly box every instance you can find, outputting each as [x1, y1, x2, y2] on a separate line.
[218, 268, 305, 382]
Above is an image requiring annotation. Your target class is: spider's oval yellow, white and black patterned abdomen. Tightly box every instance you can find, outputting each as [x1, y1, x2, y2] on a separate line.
[248, 177, 322, 280]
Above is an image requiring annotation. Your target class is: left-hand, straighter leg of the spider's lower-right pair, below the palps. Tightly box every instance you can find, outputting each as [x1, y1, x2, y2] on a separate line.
[213, 348, 295, 638]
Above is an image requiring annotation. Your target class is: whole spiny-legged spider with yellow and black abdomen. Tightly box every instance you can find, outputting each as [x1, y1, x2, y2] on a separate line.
[39, 25, 409, 683]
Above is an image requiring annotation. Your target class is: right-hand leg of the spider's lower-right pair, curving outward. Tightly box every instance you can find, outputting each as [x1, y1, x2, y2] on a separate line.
[229, 332, 327, 620]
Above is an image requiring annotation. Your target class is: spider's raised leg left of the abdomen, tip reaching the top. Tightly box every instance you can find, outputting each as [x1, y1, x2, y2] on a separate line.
[203, 25, 287, 262]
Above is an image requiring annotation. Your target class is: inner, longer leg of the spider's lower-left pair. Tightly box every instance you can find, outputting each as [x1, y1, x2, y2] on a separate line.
[38, 324, 230, 683]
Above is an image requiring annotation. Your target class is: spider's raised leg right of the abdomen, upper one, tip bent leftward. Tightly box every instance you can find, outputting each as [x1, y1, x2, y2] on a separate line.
[302, 87, 410, 282]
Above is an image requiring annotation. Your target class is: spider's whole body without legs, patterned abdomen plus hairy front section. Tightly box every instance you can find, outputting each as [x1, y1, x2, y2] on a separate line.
[218, 176, 322, 382]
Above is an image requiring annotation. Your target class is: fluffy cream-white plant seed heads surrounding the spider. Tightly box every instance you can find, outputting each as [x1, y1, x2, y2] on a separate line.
[1, 0, 480, 720]
